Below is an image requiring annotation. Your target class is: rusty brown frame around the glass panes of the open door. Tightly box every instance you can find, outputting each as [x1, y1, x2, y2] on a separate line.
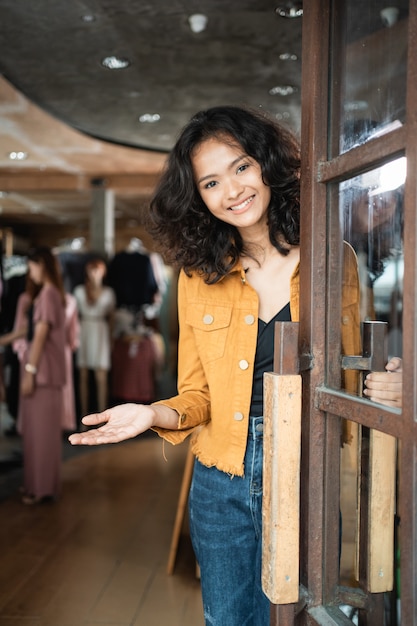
[271, 0, 417, 626]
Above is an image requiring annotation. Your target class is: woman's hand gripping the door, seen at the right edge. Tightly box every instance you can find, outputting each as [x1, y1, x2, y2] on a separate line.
[363, 357, 403, 408]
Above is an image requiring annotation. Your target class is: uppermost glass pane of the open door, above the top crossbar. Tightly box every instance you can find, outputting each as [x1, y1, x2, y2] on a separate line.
[332, 0, 408, 156]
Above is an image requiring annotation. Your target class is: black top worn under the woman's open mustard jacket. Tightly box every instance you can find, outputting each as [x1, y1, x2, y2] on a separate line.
[249, 303, 291, 417]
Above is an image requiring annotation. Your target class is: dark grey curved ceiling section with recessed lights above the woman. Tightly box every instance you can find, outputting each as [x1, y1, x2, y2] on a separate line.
[0, 0, 302, 151]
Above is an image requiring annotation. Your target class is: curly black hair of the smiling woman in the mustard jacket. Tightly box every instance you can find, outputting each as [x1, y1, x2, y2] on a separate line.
[147, 106, 300, 283]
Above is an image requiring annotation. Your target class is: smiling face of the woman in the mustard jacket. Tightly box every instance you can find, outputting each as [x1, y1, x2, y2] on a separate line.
[191, 138, 271, 238]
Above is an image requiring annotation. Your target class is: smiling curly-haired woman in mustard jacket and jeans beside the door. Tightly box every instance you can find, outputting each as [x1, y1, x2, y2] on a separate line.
[70, 107, 397, 626]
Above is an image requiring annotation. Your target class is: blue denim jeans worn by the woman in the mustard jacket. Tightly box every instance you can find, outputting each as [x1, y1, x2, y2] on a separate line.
[189, 417, 270, 626]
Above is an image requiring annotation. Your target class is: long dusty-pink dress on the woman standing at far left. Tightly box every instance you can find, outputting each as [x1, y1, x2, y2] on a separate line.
[20, 285, 66, 498]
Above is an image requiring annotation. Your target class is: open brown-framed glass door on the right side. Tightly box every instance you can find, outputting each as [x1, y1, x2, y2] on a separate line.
[264, 0, 417, 626]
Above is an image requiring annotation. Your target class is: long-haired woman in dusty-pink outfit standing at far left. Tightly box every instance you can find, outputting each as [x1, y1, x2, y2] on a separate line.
[19, 247, 66, 504]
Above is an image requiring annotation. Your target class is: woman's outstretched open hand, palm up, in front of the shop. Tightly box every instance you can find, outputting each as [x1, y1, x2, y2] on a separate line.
[68, 403, 157, 446]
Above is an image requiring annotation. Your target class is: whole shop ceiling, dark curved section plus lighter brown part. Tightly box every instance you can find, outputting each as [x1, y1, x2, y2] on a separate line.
[0, 0, 408, 245]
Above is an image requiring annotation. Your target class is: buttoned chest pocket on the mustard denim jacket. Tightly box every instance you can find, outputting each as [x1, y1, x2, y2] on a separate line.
[185, 302, 232, 363]
